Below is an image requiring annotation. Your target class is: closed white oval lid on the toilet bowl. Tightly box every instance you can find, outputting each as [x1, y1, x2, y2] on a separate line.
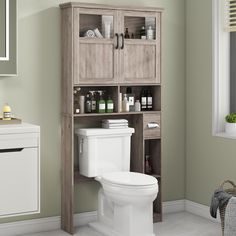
[101, 172, 157, 187]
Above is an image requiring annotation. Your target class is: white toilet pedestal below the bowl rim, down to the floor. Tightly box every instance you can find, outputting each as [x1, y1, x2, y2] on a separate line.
[89, 188, 155, 236]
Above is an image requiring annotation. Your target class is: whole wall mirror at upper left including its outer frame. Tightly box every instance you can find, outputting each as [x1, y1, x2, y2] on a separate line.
[0, 0, 17, 76]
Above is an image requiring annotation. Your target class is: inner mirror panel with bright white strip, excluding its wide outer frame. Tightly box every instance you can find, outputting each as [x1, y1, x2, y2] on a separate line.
[0, 0, 9, 61]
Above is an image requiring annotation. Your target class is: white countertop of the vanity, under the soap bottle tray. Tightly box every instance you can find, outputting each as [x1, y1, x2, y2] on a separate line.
[0, 123, 40, 135]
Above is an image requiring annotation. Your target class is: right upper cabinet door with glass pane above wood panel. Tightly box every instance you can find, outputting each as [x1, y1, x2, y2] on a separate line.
[119, 11, 161, 84]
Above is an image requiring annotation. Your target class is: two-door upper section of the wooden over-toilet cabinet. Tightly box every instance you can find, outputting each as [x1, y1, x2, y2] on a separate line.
[64, 5, 161, 85]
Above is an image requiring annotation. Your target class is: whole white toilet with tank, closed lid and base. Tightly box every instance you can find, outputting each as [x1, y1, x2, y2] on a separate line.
[76, 128, 158, 236]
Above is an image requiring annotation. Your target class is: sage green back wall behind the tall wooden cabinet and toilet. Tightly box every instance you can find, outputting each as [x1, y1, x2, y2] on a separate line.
[0, 0, 186, 222]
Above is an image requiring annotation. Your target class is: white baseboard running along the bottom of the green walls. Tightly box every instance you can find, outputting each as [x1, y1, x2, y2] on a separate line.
[0, 200, 220, 236]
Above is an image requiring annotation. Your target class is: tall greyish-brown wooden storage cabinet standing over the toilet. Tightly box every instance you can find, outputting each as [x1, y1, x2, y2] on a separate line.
[60, 3, 162, 233]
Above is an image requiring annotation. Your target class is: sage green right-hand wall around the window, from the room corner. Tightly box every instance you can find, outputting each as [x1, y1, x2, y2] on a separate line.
[186, 0, 236, 205]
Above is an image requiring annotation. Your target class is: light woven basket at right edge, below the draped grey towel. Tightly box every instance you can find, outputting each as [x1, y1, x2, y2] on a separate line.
[224, 197, 236, 236]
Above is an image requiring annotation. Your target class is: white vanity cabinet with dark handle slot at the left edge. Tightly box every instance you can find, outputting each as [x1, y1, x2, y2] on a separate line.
[0, 123, 40, 217]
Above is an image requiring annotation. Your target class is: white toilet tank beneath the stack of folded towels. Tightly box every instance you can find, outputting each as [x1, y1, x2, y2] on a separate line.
[76, 128, 134, 177]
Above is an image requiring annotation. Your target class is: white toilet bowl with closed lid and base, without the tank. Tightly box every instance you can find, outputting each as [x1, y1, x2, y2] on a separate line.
[90, 172, 158, 236]
